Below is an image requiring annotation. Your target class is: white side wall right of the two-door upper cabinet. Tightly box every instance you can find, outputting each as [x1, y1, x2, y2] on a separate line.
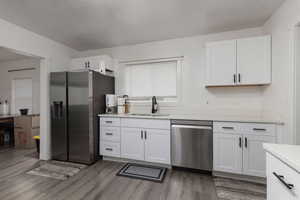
[263, 0, 300, 144]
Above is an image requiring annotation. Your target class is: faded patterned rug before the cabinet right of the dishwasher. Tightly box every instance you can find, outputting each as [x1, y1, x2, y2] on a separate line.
[214, 177, 267, 200]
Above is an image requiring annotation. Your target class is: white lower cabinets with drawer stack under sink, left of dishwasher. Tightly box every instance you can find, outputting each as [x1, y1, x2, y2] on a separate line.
[100, 117, 171, 165]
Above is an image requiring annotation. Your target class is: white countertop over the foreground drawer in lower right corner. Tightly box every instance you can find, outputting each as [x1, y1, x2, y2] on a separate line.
[263, 144, 300, 173]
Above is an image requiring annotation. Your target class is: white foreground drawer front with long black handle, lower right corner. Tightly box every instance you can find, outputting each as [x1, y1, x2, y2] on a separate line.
[267, 153, 300, 200]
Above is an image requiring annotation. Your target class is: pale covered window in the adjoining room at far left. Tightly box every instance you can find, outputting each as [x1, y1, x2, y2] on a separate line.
[12, 78, 32, 114]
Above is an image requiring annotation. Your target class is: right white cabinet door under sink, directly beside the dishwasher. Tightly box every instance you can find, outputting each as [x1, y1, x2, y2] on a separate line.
[145, 129, 171, 164]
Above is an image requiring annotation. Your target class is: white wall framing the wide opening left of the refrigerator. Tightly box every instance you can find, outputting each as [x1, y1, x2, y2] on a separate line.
[0, 19, 77, 160]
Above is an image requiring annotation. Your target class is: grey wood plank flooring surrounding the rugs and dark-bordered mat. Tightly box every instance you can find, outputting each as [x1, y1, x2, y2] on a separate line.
[0, 150, 217, 200]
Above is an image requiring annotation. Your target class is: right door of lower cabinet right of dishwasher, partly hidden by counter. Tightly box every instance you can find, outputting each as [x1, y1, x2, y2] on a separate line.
[243, 135, 275, 177]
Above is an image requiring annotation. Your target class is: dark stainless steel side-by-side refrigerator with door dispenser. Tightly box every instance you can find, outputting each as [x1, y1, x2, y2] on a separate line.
[50, 70, 115, 164]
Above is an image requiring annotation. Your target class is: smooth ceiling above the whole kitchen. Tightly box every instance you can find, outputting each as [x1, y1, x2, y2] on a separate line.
[0, 0, 284, 50]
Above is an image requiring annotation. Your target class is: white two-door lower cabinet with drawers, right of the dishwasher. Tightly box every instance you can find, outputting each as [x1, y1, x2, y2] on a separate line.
[214, 122, 276, 177]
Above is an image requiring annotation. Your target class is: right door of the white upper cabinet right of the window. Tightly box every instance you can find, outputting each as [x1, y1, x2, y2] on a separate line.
[237, 36, 271, 85]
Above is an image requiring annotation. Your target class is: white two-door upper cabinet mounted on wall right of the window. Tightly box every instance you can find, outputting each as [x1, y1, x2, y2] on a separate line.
[206, 35, 271, 86]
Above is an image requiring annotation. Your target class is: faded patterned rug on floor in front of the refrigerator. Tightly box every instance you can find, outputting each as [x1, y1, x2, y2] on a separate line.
[26, 160, 86, 180]
